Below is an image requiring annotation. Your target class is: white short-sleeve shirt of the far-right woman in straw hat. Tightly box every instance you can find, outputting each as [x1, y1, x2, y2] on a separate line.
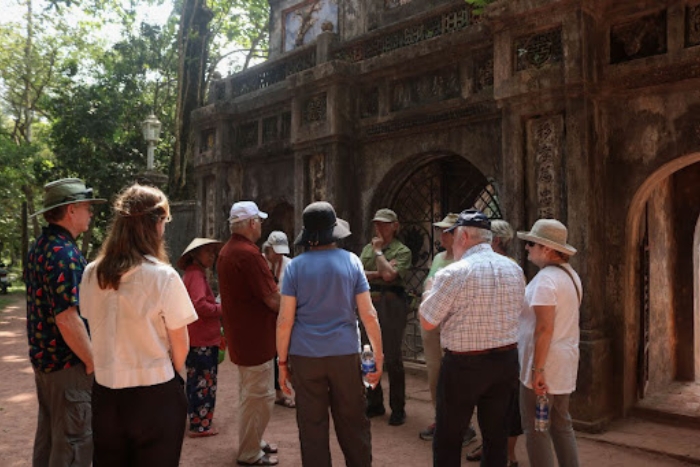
[518, 263, 583, 394]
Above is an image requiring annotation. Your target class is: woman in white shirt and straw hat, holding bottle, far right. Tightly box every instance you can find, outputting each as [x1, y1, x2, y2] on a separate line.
[518, 219, 582, 467]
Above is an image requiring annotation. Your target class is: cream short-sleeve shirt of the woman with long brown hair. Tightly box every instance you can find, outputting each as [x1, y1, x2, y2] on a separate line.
[80, 256, 197, 389]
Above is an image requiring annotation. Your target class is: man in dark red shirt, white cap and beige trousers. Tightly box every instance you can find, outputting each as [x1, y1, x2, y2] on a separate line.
[217, 201, 280, 465]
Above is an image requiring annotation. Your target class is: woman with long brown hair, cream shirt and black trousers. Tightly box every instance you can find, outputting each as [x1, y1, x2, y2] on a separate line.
[80, 184, 197, 467]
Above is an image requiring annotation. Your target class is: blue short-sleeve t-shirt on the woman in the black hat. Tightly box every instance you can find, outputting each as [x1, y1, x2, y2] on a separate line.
[282, 249, 369, 357]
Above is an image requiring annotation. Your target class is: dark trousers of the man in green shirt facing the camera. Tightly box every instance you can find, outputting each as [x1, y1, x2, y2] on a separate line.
[367, 291, 408, 413]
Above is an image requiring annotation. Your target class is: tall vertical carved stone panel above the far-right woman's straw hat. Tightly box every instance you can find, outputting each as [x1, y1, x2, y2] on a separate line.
[527, 115, 564, 219]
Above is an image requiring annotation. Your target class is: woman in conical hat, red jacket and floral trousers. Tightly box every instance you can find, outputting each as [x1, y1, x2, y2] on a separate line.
[177, 238, 223, 438]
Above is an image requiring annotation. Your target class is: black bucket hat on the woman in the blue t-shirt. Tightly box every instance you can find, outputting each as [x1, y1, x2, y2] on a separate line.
[294, 201, 350, 246]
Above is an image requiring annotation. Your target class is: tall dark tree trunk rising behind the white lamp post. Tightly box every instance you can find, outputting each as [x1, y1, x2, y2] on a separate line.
[169, 0, 213, 199]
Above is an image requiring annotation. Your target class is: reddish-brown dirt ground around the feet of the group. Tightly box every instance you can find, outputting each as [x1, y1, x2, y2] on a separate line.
[0, 295, 686, 467]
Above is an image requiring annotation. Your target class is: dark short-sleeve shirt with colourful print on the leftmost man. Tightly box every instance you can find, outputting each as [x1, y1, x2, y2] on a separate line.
[24, 224, 87, 373]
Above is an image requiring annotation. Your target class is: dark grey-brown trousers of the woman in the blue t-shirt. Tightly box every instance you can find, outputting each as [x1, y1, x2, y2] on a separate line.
[289, 354, 372, 467]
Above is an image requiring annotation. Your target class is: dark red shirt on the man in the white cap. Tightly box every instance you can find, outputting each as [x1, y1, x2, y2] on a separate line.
[217, 234, 279, 366]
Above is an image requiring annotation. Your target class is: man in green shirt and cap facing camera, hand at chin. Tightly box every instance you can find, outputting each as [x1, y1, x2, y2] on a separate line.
[360, 208, 411, 426]
